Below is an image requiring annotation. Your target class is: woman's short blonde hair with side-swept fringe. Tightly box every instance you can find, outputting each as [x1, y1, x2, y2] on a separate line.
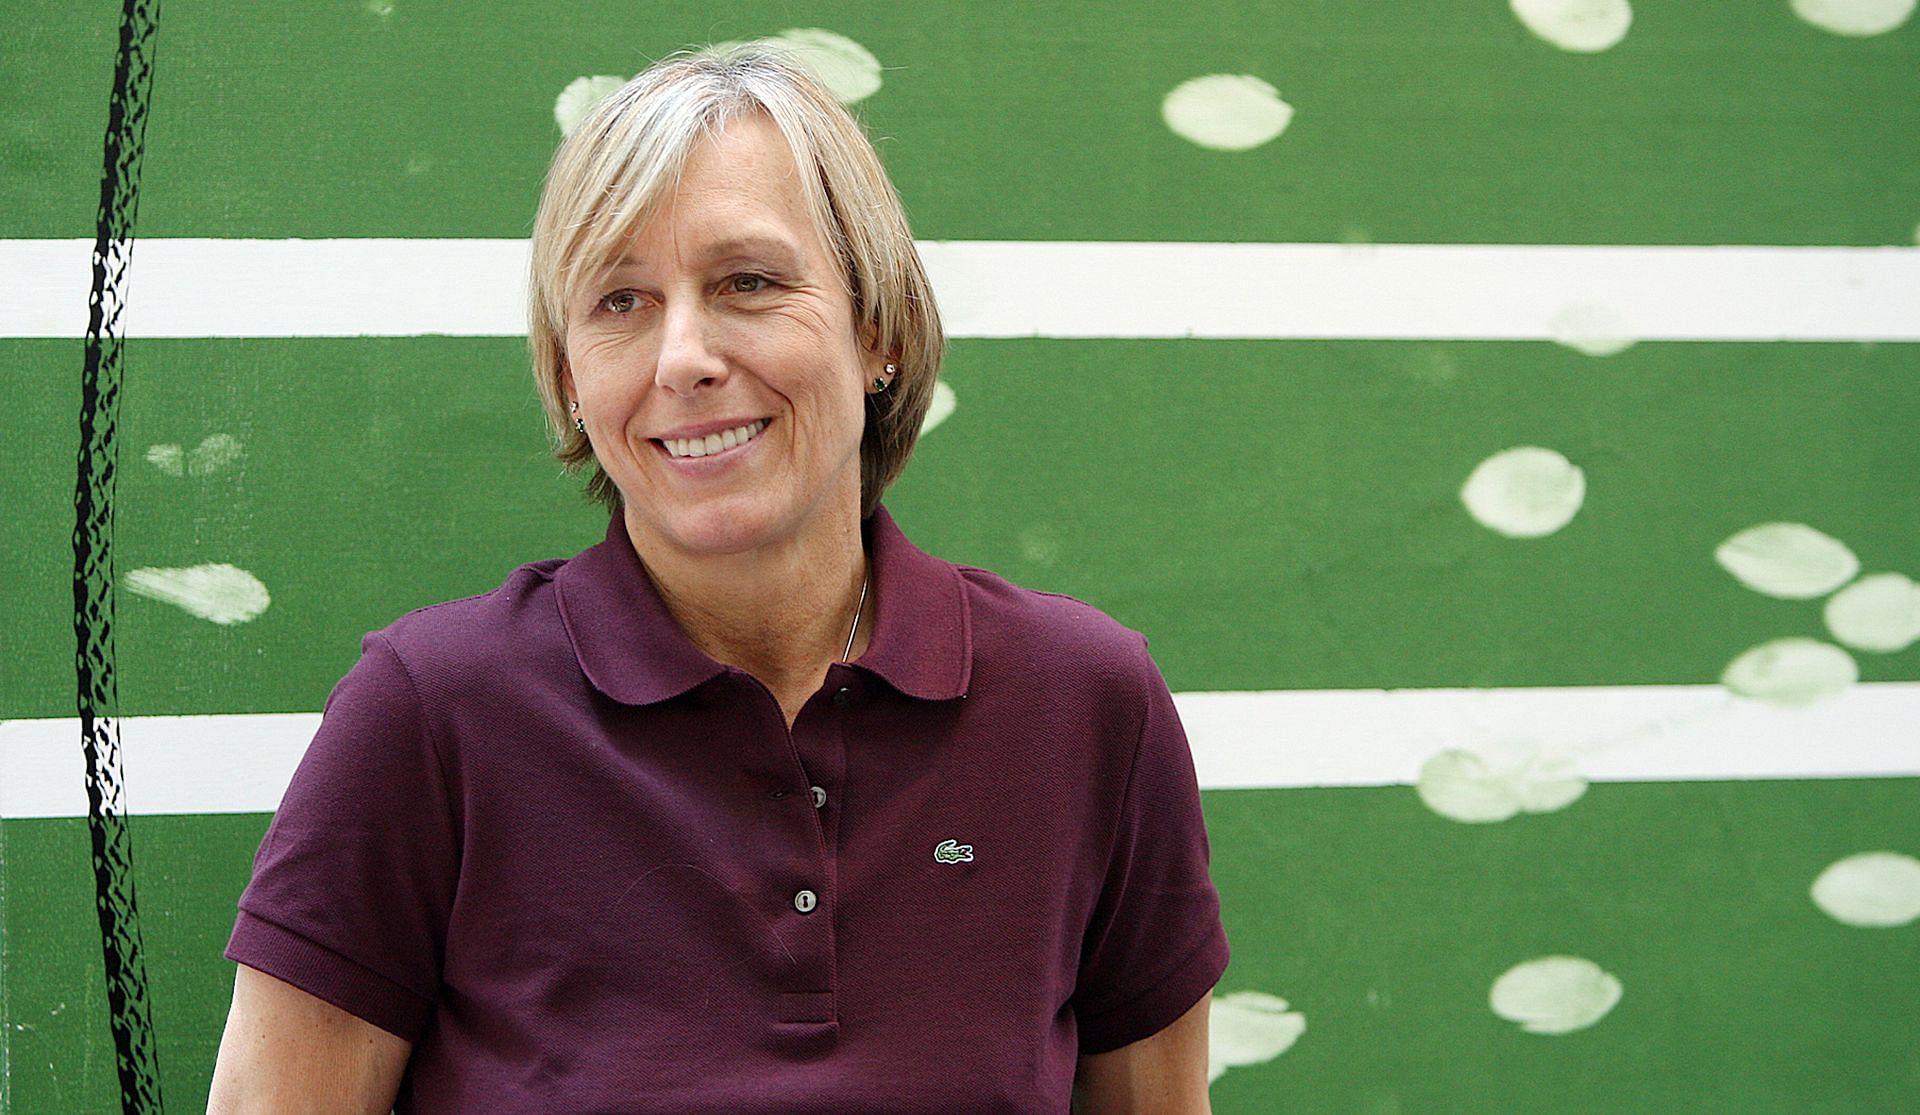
[528, 42, 947, 516]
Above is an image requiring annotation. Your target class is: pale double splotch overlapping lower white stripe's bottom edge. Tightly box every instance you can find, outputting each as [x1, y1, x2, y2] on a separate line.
[1413, 739, 1586, 825]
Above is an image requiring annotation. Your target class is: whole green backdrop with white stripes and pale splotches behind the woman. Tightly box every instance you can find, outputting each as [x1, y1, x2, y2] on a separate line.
[0, 0, 1920, 1113]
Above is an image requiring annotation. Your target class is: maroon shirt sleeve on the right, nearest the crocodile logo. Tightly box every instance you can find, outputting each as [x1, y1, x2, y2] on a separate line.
[1073, 652, 1227, 1054]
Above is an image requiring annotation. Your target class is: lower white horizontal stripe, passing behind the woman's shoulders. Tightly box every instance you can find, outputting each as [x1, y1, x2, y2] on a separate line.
[0, 681, 1920, 818]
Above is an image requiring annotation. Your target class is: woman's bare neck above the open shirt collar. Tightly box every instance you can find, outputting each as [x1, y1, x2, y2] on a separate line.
[628, 512, 874, 724]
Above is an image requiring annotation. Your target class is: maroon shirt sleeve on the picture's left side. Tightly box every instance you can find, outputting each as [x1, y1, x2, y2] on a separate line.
[227, 633, 459, 1040]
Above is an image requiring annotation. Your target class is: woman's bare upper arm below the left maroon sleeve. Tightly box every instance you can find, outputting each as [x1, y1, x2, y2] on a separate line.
[207, 965, 408, 1115]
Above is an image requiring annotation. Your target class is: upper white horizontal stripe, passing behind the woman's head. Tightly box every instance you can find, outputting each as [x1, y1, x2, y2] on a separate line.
[0, 240, 1920, 342]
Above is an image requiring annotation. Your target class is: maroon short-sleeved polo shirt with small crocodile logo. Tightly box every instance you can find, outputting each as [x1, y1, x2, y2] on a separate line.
[227, 510, 1227, 1113]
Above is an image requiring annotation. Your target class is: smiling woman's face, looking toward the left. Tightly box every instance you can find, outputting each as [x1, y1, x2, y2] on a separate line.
[563, 115, 881, 555]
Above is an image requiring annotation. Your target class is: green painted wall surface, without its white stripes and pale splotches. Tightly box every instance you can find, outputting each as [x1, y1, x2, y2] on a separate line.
[0, 0, 1920, 1115]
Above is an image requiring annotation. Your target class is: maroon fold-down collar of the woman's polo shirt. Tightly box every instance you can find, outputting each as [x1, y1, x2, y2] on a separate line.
[553, 509, 973, 704]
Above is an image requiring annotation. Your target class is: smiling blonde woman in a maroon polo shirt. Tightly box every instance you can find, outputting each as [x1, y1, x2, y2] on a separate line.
[213, 48, 1227, 1111]
